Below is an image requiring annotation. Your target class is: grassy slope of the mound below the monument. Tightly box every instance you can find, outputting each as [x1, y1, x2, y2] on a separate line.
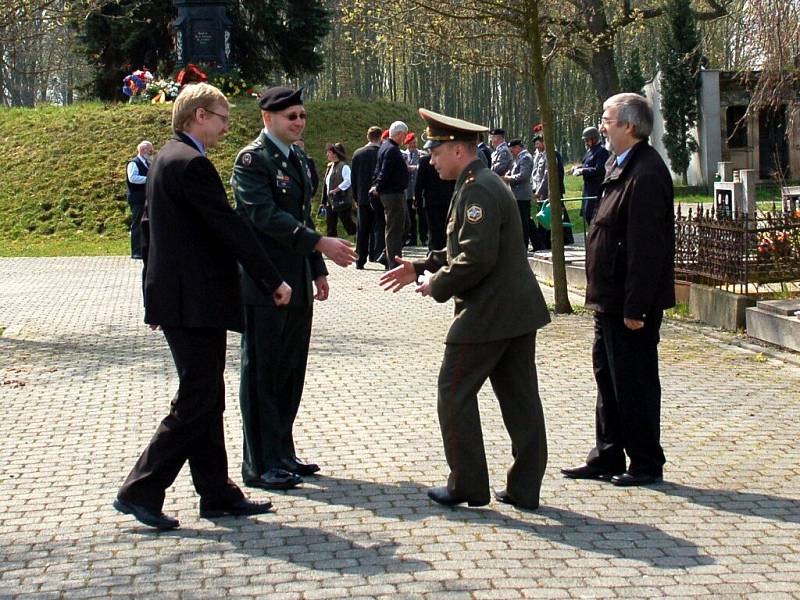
[0, 99, 421, 256]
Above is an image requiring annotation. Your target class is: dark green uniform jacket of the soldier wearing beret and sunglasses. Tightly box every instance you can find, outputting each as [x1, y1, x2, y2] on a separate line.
[231, 130, 328, 306]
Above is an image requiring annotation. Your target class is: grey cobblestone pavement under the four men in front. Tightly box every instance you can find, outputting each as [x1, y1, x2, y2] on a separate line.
[0, 257, 800, 600]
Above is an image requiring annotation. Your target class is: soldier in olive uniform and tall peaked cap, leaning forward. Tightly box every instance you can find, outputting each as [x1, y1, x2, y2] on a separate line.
[380, 108, 550, 509]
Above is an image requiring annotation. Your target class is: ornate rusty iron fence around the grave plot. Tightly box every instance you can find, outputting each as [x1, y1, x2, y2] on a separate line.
[675, 206, 800, 293]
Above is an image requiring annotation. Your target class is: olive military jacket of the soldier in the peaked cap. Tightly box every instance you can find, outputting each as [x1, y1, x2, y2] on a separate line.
[414, 158, 550, 343]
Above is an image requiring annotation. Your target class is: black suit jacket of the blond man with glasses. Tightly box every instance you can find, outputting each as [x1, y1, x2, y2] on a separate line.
[142, 132, 282, 331]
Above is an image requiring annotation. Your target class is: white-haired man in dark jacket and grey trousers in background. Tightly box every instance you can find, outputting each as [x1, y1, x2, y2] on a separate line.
[370, 121, 408, 269]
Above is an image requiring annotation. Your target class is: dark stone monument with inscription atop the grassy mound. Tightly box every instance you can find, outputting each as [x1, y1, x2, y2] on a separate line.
[172, 0, 232, 71]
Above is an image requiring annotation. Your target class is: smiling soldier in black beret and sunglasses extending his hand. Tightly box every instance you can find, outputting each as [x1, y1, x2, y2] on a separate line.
[231, 87, 356, 489]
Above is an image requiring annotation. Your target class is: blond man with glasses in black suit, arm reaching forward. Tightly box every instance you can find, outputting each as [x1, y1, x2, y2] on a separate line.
[114, 83, 291, 529]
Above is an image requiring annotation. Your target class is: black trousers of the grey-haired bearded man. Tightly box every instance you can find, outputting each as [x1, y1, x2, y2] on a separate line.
[586, 312, 666, 475]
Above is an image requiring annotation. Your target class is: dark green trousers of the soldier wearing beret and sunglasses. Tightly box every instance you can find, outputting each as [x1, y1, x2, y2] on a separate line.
[239, 304, 313, 481]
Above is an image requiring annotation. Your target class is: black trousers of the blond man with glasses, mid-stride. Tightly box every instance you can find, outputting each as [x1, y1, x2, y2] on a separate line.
[119, 327, 243, 511]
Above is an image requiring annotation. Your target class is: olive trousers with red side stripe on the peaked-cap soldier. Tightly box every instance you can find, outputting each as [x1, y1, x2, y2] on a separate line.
[438, 332, 547, 506]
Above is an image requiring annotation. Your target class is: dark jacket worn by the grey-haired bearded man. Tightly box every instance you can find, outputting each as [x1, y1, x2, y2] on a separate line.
[586, 141, 675, 321]
